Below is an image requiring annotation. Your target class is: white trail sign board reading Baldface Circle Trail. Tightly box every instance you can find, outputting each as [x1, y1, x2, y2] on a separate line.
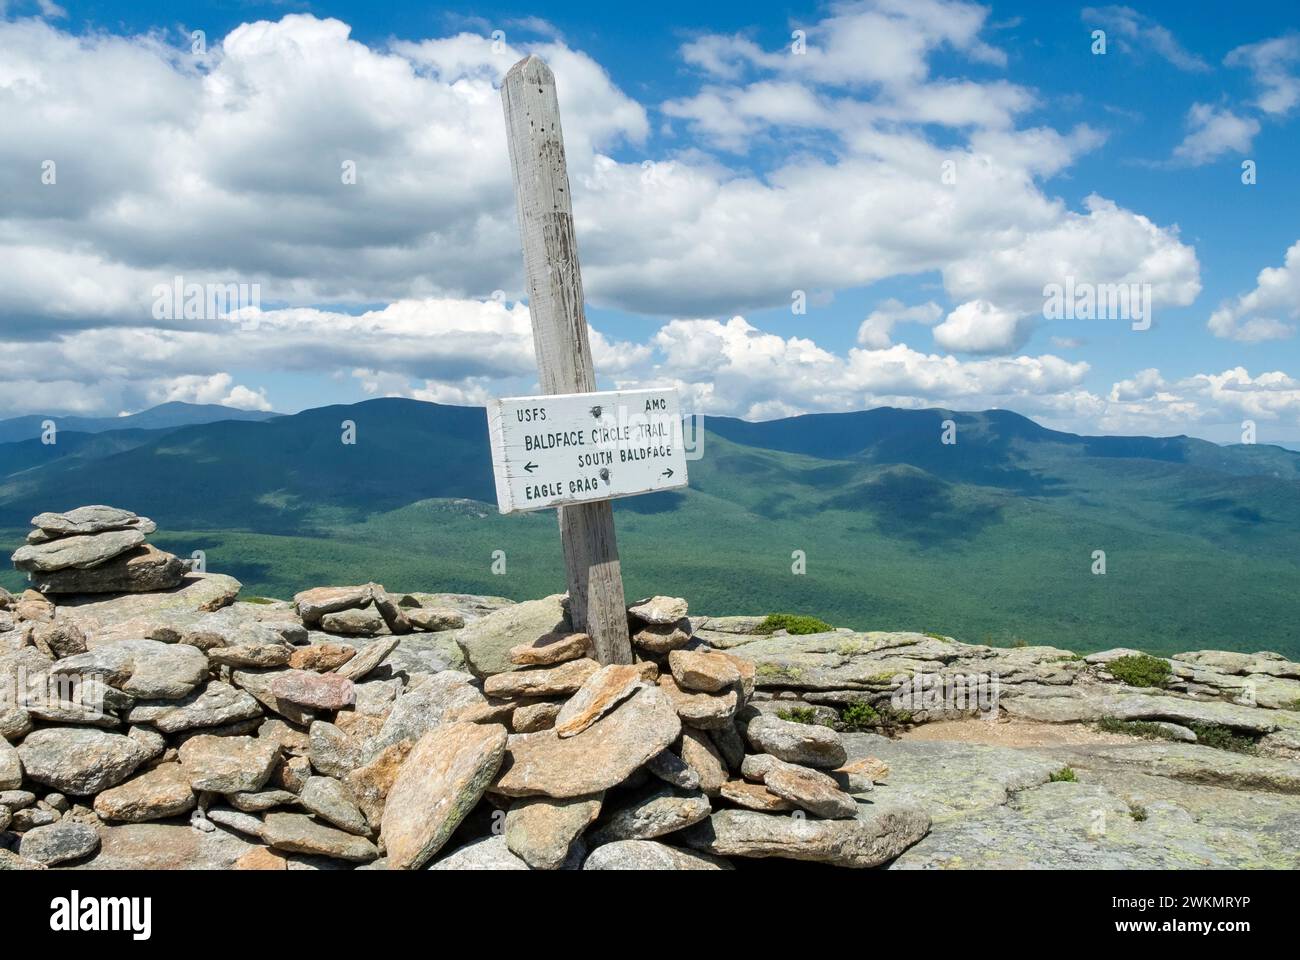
[488, 389, 686, 514]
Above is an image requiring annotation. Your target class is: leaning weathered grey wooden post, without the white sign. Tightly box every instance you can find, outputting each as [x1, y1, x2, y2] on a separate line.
[501, 56, 632, 663]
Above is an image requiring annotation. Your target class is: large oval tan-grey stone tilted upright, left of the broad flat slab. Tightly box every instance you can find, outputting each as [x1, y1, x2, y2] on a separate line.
[380, 723, 506, 870]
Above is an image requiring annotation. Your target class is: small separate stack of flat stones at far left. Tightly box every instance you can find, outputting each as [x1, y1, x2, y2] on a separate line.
[13, 506, 189, 593]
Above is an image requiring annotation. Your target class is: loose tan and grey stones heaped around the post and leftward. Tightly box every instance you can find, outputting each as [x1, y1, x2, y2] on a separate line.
[0, 507, 930, 869]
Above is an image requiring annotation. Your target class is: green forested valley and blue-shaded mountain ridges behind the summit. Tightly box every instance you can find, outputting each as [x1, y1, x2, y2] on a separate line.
[0, 398, 1300, 653]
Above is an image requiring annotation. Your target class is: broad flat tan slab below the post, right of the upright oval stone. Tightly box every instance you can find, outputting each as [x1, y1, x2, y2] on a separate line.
[493, 688, 681, 799]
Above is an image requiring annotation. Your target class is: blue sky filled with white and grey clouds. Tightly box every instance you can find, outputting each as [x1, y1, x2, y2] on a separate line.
[0, 0, 1300, 442]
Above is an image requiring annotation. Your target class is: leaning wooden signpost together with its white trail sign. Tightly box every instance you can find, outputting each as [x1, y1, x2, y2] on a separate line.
[491, 56, 686, 663]
